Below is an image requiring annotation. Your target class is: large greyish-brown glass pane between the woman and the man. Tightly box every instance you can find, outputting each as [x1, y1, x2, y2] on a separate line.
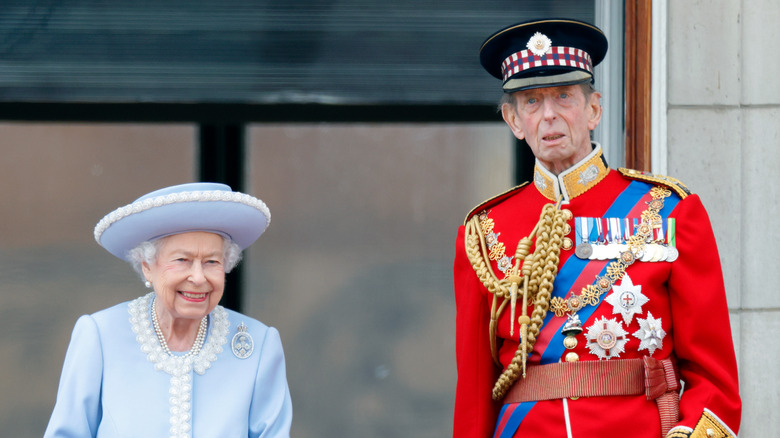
[244, 123, 513, 438]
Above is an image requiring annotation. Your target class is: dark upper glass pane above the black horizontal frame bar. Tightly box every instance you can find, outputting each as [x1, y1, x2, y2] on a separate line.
[0, 0, 594, 104]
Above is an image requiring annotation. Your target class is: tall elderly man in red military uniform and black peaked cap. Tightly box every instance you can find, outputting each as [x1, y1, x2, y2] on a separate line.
[454, 19, 741, 438]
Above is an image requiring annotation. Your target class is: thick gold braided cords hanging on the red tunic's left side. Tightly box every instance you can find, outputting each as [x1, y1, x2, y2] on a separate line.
[465, 204, 571, 400]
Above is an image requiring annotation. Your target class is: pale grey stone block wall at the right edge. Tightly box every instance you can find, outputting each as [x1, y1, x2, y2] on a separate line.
[666, 0, 780, 438]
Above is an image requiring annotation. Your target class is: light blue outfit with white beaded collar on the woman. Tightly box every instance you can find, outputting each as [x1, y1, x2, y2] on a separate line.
[44, 293, 292, 438]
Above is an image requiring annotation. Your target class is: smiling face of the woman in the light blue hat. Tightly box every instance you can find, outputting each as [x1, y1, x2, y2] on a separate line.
[143, 231, 225, 320]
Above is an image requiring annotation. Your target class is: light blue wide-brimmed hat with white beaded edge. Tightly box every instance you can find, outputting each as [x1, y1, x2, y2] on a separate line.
[95, 183, 271, 260]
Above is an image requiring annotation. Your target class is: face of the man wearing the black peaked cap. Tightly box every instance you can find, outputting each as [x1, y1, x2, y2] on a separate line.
[501, 85, 601, 174]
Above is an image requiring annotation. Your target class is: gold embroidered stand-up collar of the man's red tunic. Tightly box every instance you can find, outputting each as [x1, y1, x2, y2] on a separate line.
[534, 142, 609, 203]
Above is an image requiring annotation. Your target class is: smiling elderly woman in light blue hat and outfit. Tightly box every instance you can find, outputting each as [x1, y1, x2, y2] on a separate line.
[45, 183, 292, 437]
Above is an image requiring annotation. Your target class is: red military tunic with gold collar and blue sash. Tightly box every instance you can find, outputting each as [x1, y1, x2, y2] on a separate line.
[454, 145, 741, 438]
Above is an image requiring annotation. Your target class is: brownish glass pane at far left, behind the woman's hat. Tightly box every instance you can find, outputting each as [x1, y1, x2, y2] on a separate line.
[0, 123, 196, 438]
